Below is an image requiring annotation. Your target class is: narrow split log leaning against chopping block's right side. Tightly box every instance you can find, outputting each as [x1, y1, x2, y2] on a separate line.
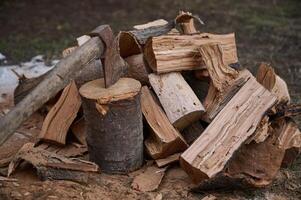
[141, 86, 188, 159]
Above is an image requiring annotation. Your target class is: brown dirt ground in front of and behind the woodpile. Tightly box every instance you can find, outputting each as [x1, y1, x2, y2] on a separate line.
[0, 0, 301, 200]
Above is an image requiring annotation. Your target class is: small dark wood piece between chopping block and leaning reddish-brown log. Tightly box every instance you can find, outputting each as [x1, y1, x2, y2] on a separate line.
[70, 117, 87, 146]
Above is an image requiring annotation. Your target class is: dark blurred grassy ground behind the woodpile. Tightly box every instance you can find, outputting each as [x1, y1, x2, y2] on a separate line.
[0, 0, 301, 109]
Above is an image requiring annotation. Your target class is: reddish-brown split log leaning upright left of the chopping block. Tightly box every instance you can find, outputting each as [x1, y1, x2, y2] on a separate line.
[38, 82, 81, 144]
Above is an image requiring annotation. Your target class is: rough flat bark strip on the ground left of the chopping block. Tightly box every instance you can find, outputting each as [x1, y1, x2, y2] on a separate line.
[8, 143, 99, 182]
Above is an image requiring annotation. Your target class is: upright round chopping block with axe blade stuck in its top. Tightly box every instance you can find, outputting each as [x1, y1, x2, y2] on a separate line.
[80, 78, 143, 173]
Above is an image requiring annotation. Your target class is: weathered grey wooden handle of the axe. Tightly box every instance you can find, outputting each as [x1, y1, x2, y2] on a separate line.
[0, 37, 104, 145]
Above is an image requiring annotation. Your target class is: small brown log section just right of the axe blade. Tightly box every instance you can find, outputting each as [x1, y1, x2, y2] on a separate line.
[125, 54, 151, 85]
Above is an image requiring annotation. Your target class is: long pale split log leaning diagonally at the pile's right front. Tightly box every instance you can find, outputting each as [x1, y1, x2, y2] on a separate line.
[180, 77, 276, 183]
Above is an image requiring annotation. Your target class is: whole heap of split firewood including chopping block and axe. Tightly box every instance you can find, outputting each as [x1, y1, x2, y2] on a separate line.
[0, 12, 301, 188]
